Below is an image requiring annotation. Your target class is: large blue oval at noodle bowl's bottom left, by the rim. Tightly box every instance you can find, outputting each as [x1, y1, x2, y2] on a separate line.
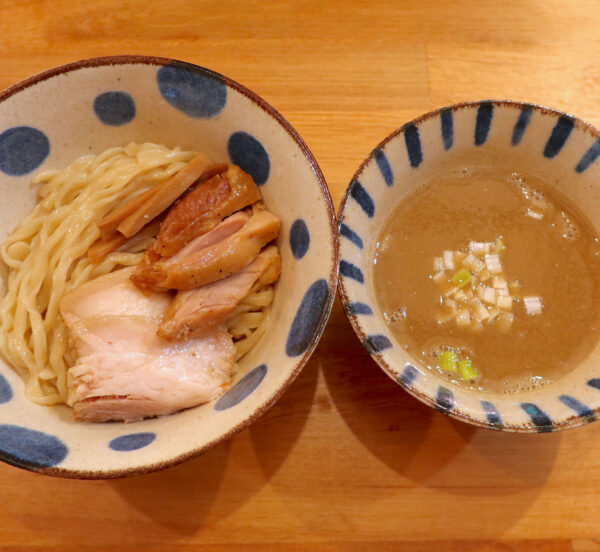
[0, 424, 69, 470]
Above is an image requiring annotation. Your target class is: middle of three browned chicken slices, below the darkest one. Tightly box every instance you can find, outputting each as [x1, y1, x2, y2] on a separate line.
[132, 208, 280, 291]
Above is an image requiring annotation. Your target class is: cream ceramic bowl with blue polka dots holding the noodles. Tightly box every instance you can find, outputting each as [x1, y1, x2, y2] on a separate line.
[0, 56, 338, 478]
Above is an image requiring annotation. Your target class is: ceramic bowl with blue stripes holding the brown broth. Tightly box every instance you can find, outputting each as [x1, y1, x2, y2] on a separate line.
[338, 101, 600, 433]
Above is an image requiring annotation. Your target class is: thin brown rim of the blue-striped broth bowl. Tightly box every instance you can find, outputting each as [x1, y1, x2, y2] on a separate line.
[337, 99, 600, 434]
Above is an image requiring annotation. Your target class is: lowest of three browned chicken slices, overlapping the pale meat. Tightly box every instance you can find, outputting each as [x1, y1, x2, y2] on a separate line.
[158, 246, 281, 339]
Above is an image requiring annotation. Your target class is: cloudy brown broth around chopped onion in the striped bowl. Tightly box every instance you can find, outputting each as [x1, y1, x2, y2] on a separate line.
[373, 167, 600, 392]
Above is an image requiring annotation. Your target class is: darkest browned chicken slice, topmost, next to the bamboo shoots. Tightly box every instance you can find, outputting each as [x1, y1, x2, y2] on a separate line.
[153, 165, 260, 257]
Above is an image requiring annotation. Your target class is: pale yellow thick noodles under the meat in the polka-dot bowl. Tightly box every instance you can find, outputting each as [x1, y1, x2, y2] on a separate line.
[0, 144, 273, 405]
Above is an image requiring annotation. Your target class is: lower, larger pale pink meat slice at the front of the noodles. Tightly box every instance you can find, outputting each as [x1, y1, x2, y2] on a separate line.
[68, 316, 235, 422]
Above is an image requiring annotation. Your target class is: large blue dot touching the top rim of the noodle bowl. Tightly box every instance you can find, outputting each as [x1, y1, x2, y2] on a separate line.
[156, 63, 227, 119]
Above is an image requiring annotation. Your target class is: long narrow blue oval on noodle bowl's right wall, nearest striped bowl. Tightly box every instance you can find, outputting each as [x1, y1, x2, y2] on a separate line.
[285, 279, 329, 357]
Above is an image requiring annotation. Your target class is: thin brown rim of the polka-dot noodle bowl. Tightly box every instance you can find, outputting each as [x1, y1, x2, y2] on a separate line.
[0, 54, 339, 479]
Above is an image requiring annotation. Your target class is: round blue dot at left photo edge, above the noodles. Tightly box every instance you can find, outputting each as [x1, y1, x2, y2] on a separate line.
[0, 126, 50, 176]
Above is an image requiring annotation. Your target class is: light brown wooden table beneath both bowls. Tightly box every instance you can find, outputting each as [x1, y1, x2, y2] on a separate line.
[0, 0, 600, 552]
